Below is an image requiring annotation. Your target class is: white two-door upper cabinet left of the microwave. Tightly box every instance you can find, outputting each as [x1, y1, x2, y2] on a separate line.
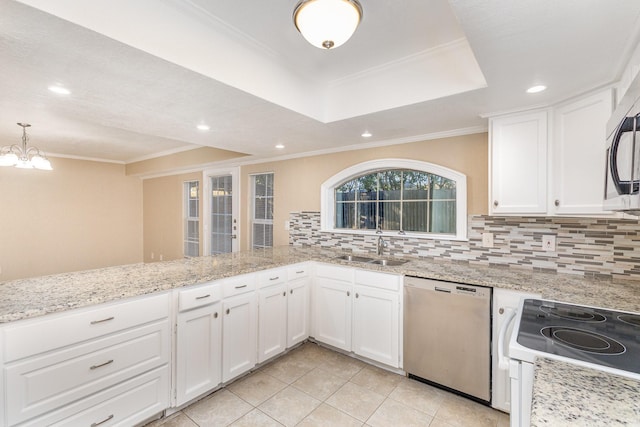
[489, 89, 613, 215]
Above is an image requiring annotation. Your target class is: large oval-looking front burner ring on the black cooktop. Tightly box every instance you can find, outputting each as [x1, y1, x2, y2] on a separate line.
[540, 326, 626, 355]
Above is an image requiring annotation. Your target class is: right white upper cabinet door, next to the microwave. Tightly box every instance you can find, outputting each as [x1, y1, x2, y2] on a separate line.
[550, 89, 613, 215]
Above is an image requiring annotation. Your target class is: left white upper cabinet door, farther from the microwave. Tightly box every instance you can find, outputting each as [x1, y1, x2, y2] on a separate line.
[489, 110, 548, 214]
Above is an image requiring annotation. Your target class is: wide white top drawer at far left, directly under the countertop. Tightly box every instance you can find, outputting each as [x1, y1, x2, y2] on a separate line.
[2, 293, 169, 363]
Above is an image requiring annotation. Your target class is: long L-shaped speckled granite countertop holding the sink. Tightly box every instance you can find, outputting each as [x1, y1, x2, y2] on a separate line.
[0, 246, 640, 323]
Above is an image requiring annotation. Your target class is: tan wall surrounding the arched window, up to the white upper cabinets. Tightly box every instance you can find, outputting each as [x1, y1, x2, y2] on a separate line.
[241, 133, 489, 249]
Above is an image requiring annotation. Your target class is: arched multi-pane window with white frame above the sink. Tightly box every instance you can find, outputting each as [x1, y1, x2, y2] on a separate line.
[321, 159, 467, 239]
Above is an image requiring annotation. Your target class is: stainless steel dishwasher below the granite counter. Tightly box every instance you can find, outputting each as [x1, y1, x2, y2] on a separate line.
[404, 277, 491, 403]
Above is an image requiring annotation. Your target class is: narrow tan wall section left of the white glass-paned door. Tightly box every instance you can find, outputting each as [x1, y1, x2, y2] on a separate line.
[143, 173, 202, 262]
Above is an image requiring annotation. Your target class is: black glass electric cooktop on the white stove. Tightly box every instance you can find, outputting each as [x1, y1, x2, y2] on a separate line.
[517, 299, 640, 374]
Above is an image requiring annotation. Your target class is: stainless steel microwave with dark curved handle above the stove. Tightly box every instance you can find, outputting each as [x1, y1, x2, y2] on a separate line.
[604, 75, 640, 215]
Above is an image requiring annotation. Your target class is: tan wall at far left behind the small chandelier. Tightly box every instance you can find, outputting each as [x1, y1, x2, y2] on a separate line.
[0, 158, 142, 281]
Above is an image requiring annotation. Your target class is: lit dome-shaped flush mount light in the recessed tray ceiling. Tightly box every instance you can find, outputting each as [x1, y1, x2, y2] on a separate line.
[293, 0, 362, 49]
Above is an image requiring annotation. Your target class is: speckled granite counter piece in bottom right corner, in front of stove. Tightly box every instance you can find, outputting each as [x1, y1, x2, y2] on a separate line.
[531, 359, 640, 427]
